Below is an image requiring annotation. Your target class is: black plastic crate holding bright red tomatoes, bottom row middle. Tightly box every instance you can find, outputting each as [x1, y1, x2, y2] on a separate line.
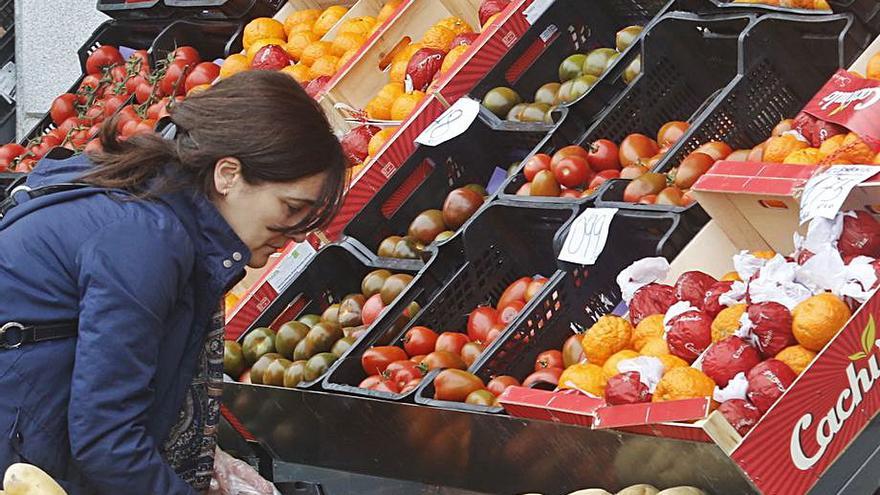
[323, 201, 578, 402]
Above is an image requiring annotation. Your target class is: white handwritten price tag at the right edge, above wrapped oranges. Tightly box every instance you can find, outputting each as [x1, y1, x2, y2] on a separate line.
[800, 165, 878, 224]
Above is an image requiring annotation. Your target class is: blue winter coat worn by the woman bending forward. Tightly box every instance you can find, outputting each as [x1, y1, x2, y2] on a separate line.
[0, 153, 250, 495]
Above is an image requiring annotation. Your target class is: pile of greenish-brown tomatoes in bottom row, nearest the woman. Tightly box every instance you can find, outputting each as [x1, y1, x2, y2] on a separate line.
[223, 269, 419, 388]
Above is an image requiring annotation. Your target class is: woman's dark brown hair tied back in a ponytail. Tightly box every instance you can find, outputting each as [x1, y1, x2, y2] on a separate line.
[83, 71, 347, 233]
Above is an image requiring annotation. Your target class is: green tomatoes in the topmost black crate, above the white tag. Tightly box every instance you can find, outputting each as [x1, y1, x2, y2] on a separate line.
[482, 26, 642, 123]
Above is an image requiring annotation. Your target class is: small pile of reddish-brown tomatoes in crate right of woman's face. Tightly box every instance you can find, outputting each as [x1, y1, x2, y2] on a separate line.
[377, 184, 487, 259]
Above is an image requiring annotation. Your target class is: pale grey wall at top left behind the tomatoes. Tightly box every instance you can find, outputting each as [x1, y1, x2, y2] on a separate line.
[15, 0, 108, 138]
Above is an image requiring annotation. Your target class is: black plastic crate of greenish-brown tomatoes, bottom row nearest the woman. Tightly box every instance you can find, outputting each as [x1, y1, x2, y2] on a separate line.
[238, 240, 459, 389]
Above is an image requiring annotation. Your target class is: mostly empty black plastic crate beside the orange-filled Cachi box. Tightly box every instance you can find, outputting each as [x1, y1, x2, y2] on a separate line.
[416, 211, 690, 413]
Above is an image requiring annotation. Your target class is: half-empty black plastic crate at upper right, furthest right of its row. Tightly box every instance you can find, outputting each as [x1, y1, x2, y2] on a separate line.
[596, 14, 870, 220]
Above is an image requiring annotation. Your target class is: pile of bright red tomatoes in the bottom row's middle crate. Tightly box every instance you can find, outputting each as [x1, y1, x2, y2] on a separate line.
[358, 275, 547, 396]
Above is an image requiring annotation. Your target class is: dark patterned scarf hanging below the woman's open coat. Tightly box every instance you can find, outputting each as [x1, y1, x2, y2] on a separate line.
[163, 303, 226, 492]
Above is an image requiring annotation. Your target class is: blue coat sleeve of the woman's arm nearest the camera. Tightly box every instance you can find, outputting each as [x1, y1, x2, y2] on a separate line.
[68, 219, 196, 495]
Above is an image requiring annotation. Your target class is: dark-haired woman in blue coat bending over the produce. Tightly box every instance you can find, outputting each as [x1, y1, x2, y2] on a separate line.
[0, 72, 345, 495]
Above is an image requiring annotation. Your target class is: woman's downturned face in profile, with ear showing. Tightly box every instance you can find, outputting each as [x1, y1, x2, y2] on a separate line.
[213, 158, 325, 268]
